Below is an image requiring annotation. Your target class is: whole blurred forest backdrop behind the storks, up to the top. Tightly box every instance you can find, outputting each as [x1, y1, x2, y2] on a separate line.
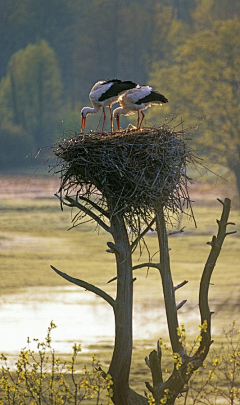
[0, 0, 240, 197]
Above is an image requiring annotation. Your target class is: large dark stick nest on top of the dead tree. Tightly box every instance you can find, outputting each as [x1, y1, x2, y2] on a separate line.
[54, 126, 194, 232]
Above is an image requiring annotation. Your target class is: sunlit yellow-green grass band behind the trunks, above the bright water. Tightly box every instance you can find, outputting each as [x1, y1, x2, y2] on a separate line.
[0, 199, 240, 306]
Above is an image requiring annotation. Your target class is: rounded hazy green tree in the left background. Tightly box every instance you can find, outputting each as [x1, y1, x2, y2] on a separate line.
[0, 40, 62, 145]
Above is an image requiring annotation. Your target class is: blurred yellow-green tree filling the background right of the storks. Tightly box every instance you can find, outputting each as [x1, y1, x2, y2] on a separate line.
[148, 0, 240, 199]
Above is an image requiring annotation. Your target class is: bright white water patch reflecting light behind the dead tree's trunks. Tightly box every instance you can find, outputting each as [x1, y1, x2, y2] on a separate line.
[0, 286, 201, 354]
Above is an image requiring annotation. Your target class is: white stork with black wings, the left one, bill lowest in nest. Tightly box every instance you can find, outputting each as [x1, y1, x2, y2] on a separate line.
[81, 79, 137, 135]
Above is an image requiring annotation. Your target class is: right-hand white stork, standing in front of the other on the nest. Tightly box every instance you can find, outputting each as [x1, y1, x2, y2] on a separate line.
[113, 86, 168, 130]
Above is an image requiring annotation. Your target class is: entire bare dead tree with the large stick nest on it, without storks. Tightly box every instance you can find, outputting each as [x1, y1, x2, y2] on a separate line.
[49, 126, 235, 405]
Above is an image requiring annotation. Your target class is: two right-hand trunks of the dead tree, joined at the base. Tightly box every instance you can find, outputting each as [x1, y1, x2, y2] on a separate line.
[143, 198, 235, 405]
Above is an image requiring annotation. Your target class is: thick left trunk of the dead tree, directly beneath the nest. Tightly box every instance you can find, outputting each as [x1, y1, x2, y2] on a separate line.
[109, 215, 133, 405]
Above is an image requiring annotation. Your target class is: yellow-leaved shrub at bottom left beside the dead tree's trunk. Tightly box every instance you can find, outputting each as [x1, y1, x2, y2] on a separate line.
[0, 322, 112, 405]
